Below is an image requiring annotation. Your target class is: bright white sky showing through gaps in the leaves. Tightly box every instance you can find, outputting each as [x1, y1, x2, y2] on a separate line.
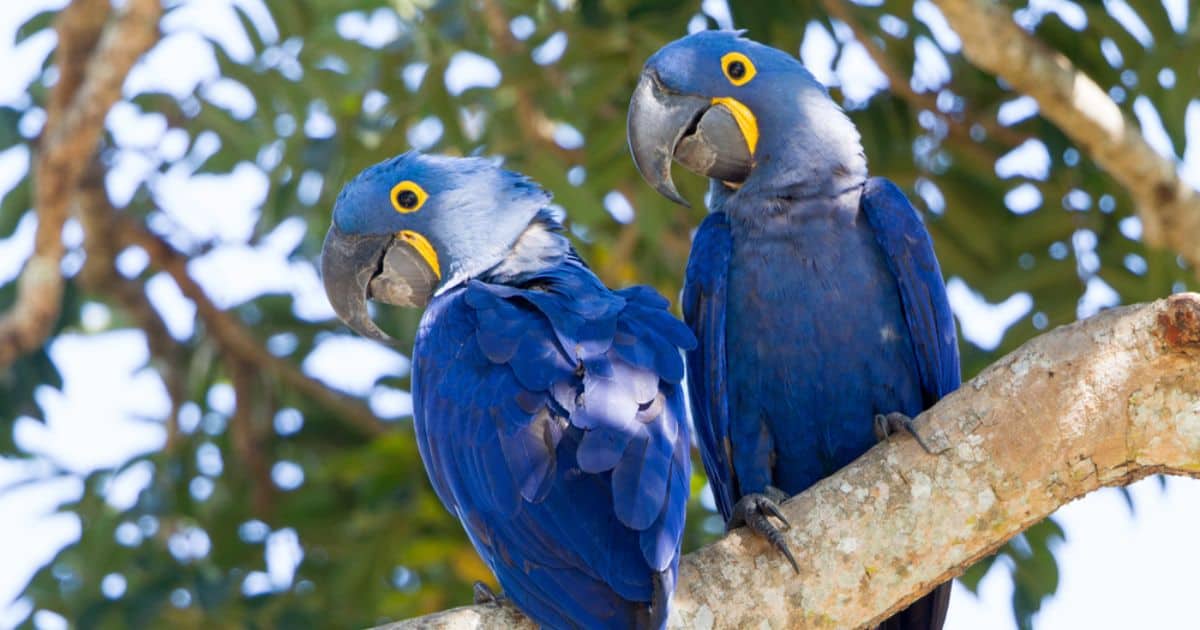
[0, 0, 1200, 630]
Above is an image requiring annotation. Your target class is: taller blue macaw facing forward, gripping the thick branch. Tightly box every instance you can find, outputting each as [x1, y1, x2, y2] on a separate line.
[629, 31, 960, 629]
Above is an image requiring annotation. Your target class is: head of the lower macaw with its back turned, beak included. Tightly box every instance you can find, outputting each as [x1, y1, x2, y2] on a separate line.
[320, 151, 550, 341]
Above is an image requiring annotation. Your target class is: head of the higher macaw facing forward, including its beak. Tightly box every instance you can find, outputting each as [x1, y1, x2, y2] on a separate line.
[628, 31, 865, 205]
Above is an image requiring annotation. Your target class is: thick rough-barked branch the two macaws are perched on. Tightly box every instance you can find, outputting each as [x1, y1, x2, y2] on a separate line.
[376, 293, 1200, 630]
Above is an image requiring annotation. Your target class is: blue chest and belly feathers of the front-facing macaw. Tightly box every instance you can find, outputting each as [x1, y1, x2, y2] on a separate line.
[726, 194, 922, 494]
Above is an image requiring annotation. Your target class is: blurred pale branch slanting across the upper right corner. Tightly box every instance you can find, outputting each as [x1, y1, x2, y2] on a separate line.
[934, 0, 1200, 272]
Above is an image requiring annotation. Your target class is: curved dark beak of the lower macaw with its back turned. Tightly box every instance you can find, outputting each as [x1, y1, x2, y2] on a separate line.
[320, 223, 440, 342]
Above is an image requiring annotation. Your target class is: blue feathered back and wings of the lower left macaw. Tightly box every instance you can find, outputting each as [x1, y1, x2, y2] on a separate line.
[413, 262, 695, 628]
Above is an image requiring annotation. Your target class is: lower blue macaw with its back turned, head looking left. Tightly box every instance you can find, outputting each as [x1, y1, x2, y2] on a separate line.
[322, 152, 696, 629]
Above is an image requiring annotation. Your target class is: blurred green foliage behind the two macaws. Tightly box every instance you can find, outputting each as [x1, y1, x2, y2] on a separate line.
[0, 0, 1200, 628]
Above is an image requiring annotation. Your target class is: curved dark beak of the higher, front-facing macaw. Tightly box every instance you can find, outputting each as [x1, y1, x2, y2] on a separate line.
[626, 70, 754, 205]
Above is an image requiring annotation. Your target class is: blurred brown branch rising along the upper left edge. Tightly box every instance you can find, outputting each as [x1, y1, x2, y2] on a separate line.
[0, 0, 162, 370]
